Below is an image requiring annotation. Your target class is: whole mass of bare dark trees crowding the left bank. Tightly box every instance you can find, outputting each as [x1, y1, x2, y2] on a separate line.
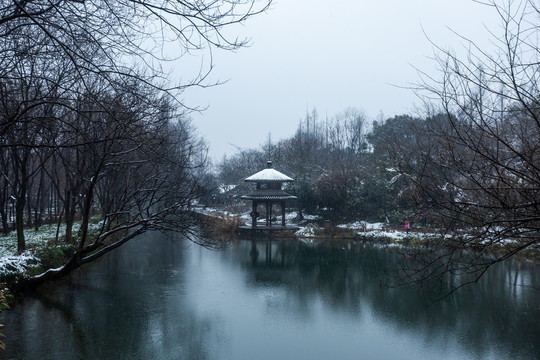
[0, 0, 270, 286]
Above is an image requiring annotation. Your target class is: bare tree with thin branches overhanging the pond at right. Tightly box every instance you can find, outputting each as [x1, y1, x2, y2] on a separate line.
[400, 0, 540, 289]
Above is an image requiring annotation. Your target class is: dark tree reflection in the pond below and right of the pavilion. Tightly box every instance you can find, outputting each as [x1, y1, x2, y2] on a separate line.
[237, 241, 540, 358]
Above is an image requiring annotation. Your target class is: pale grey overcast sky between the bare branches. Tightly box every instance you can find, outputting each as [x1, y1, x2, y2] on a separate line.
[182, 0, 497, 161]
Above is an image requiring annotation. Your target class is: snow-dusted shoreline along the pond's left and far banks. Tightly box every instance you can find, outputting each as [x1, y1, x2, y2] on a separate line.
[0, 209, 540, 298]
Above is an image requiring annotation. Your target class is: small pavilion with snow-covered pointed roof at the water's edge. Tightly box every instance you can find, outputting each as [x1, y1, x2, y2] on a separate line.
[241, 161, 296, 230]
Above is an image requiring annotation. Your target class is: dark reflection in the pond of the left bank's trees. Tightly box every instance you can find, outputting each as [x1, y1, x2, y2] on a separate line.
[6, 234, 219, 359]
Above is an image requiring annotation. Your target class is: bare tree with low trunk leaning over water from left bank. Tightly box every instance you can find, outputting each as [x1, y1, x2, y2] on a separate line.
[21, 87, 211, 287]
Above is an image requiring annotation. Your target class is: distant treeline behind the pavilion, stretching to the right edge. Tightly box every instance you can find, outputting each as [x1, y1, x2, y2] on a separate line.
[207, 106, 540, 236]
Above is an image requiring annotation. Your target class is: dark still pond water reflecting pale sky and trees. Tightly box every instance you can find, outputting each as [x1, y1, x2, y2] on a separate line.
[0, 234, 540, 360]
